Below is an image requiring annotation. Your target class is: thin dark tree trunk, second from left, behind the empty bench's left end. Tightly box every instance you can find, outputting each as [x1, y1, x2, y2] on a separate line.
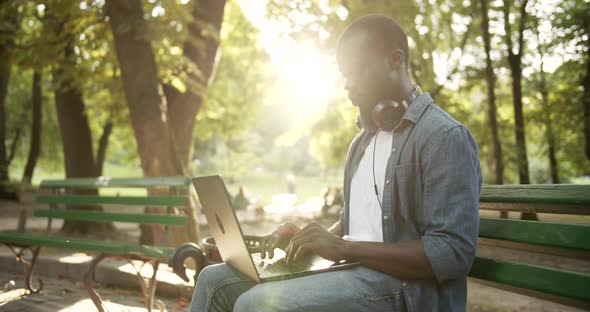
[22, 69, 42, 184]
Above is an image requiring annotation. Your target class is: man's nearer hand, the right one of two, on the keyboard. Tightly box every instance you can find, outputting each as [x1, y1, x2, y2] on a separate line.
[285, 222, 345, 264]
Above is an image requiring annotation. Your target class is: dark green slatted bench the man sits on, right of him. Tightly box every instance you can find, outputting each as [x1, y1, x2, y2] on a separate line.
[469, 185, 590, 309]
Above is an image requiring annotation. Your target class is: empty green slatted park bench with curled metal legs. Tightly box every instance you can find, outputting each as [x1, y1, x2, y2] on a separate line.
[0, 177, 198, 311]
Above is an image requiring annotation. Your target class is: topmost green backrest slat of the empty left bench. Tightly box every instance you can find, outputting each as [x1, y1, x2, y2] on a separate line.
[40, 176, 191, 188]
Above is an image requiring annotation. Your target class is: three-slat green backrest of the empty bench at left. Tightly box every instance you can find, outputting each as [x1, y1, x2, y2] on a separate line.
[33, 176, 192, 235]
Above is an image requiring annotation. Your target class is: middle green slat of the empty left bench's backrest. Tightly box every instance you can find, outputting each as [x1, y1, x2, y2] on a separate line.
[36, 195, 187, 207]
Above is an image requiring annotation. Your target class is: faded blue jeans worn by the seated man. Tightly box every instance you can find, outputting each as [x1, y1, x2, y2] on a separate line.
[190, 263, 406, 312]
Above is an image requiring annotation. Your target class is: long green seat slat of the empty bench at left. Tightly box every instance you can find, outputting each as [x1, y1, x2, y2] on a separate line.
[0, 232, 174, 258]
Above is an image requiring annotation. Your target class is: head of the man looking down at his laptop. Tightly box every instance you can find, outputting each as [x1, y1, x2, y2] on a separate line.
[337, 14, 411, 115]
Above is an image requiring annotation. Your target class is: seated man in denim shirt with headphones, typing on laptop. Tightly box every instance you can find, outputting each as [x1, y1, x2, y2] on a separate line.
[191, 15, 482, 311]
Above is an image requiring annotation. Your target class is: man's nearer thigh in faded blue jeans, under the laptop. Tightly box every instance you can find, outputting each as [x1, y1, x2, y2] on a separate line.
[234, 266, 406, 312]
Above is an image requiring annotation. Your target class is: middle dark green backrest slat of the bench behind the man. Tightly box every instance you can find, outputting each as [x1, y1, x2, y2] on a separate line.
[478, 218, 590, 251]
